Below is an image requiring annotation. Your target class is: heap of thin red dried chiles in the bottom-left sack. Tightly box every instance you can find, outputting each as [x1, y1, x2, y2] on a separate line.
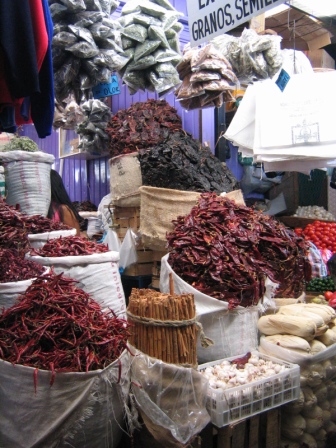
[0, 272, 130, 376]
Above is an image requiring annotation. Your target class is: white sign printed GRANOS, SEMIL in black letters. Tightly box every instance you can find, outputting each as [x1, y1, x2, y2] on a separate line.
[187, 0, 285, 47]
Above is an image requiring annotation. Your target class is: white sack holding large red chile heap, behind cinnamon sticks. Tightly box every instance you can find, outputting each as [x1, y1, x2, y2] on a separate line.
[160, 254, 260, 364]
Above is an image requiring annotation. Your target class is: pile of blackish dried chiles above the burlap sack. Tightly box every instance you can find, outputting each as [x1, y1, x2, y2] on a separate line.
[139, 130, 239, 193]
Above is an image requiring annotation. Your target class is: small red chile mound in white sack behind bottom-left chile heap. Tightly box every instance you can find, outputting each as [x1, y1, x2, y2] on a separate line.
[30, 236, 109, 257]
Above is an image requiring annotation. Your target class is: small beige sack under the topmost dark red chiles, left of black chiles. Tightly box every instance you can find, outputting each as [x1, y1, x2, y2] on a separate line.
[109, 152, 142, 207]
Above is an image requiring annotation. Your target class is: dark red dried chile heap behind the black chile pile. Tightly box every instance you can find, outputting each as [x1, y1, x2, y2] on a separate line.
[106, 99, 182, 157]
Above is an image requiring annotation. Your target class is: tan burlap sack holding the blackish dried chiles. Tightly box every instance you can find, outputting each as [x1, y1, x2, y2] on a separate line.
[139, 186, 245, 251]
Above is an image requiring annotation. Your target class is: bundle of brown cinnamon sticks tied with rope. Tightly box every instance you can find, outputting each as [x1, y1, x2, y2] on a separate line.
[127, 288, 197, 367]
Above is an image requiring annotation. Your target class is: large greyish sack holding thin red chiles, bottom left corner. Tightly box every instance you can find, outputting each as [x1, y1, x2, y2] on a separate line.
[0, 351, 130, 448]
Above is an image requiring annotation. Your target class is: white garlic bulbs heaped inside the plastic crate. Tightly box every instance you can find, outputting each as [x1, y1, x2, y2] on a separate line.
[200, 353, 287, 390]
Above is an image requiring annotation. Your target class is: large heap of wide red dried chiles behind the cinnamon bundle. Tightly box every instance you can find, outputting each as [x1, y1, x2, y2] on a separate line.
[167, 193, 311, 308]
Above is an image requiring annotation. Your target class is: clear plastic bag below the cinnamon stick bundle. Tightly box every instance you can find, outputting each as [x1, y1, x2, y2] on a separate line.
[131, 347, 210, 446]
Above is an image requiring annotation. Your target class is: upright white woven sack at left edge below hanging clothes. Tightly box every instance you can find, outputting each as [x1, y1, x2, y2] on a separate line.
[0, 151, 55, 216]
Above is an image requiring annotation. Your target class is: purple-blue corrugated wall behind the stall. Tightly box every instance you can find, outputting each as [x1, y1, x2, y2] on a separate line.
[22, 0, 215, 205]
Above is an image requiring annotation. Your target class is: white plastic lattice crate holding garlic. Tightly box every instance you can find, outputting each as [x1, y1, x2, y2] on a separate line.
[198, 352, 300, 428]
